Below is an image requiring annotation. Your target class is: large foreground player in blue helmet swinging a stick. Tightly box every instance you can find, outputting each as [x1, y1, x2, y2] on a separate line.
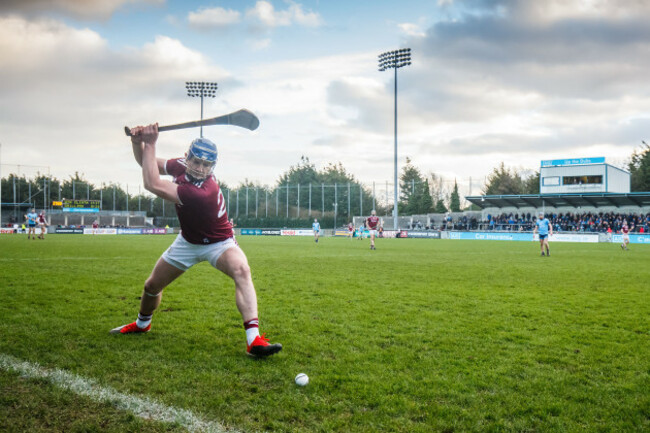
[111, 124, 282, 356]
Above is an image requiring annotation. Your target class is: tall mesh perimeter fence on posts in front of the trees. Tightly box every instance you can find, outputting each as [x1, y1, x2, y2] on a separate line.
[0, 165, 483, 228]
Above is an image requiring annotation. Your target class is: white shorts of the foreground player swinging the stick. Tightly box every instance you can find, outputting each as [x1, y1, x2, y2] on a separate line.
[162, 234, 237, 271]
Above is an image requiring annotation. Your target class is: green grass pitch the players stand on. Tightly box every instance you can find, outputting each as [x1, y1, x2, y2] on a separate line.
[0, 235, 650, 432]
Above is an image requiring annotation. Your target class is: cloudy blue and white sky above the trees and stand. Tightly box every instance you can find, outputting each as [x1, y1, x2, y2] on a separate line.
[0, 0, 650, 193]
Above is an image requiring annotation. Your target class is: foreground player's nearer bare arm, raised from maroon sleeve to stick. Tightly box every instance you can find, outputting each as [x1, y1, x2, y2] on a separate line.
[139, 123, 180, 203]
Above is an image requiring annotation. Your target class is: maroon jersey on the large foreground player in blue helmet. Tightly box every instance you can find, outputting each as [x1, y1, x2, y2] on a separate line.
[165, 158, 233, 244]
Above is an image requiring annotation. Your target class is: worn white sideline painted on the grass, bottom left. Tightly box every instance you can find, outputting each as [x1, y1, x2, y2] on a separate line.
[0, 353, 235, 433]
